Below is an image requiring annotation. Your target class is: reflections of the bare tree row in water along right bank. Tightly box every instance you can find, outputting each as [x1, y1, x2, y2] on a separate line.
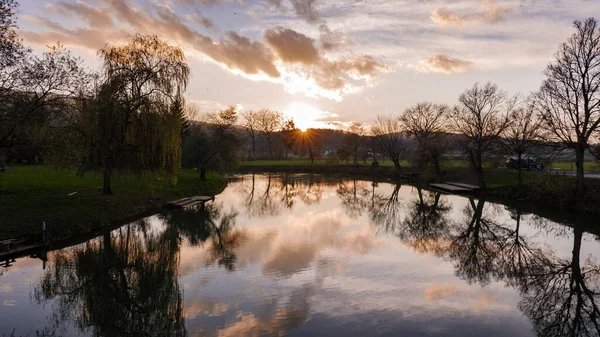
[366, 182, 600, 337]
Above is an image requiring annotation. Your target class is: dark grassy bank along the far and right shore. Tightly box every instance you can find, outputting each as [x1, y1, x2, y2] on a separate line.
[238, 161, 600, 215]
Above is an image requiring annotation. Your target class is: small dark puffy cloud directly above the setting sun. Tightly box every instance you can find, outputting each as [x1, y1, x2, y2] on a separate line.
[265, 27, 320, 65]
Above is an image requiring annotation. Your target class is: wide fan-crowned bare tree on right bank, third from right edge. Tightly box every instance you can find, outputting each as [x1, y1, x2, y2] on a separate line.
[450, 82, 517, 191]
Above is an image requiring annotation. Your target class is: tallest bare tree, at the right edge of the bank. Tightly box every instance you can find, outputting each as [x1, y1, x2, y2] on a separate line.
[536, 18, 600, 197]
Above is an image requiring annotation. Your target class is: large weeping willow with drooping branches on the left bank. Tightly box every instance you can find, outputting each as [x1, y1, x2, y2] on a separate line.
[81, 34, 190, 194]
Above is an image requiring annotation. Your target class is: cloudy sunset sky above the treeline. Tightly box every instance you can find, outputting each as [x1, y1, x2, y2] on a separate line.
[19, 0, 600, 128]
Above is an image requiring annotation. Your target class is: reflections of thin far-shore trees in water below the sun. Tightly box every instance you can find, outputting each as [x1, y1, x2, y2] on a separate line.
[239, 174, 326, 216]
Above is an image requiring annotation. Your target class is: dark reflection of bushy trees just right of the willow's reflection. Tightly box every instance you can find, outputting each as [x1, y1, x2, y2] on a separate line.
[164, 203, 246, 270]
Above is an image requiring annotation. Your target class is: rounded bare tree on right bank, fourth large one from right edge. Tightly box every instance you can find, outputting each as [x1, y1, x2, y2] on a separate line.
[400, 102, 450, 177]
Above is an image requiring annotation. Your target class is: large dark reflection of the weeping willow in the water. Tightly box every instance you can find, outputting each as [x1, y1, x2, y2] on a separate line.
[34, 222, 186, 336]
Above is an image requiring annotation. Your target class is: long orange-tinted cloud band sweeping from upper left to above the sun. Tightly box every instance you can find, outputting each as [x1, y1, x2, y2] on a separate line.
[21, 0, 388, 101]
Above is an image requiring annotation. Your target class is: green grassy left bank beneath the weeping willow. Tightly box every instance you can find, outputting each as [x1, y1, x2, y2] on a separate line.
[0, 166, 227, 241]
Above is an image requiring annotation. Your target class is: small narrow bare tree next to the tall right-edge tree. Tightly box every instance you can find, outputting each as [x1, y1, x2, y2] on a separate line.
[501, 103, 546, 189]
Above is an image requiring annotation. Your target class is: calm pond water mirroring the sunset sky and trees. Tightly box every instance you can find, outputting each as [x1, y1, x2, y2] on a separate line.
[0, 175, 600, 337]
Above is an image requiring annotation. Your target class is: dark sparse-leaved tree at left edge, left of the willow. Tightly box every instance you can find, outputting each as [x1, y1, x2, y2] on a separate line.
[0, 44, 91, 149]
